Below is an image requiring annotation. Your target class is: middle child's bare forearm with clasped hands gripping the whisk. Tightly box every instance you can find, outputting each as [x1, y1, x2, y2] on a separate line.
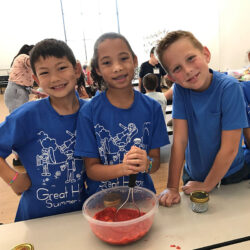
[84, 147, 148, 181]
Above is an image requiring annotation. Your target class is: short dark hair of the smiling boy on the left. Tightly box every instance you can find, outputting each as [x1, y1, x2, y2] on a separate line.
[30, 39, 76, 75]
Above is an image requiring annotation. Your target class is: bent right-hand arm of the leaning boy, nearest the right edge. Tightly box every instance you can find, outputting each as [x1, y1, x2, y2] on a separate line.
[182, 129, 241, 194]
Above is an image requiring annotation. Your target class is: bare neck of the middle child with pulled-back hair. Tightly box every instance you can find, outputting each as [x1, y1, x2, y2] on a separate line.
[106, 88, 134, 109]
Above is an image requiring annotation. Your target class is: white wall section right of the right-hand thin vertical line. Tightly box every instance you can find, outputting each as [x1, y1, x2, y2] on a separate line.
[119, 0, 250, 71]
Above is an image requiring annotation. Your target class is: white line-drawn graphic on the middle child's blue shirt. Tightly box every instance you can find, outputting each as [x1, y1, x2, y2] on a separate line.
[95, 122, 150, 189]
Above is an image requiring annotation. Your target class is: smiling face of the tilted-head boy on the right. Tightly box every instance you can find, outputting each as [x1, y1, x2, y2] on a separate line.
[162, 38, 212, 91]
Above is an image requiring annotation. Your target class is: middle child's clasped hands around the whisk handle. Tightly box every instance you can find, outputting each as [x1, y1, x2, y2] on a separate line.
[123, 146, 148, 175]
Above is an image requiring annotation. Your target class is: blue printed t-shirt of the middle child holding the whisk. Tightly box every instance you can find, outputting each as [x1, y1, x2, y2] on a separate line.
[75, 91, 169, 195]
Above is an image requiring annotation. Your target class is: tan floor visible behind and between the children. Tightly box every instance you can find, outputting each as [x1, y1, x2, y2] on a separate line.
[0, 89, 172, 224]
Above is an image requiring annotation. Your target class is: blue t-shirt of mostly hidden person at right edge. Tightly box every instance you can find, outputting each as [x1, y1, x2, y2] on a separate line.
[240, 81, 250, 165]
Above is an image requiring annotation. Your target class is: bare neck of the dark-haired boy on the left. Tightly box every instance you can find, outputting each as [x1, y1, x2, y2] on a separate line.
[50, 95, 80, 115]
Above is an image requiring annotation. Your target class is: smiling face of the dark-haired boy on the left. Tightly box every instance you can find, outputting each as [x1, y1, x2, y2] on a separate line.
[33, 56, 81, 99]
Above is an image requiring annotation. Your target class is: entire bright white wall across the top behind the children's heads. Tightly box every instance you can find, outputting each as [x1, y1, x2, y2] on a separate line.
[0, 0, 250, 70]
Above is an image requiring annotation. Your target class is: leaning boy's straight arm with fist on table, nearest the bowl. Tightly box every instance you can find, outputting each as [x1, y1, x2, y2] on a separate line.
[159, 119, 188, 207]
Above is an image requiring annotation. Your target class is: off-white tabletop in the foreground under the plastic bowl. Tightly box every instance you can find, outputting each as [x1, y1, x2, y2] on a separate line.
[0, 181, 250, 250]
